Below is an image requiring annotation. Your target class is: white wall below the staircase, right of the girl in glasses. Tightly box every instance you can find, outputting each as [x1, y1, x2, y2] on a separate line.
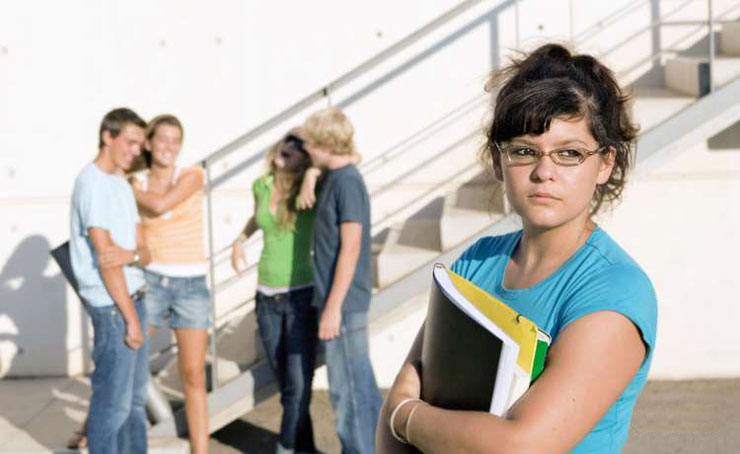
[604, 123, 740, 379]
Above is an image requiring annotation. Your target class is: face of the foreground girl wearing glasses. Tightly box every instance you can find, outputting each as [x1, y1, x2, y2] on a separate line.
[501, 118, 614, 230]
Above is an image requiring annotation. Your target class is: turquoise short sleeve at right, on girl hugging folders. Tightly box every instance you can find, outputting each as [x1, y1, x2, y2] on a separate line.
[558, 264, 657, 360]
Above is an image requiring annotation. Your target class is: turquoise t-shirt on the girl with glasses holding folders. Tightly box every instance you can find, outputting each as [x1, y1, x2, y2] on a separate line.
[452, 227, 657, 454]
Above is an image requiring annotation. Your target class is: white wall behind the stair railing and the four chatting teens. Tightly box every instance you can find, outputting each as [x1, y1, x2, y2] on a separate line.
[0, 0, 727, 376]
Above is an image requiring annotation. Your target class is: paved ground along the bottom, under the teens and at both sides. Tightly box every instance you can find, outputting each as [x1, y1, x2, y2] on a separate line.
[0, 378, 740, 454]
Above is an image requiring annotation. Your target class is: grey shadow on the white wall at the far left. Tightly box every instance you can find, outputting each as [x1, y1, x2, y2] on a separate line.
[0, 235, 81, 377]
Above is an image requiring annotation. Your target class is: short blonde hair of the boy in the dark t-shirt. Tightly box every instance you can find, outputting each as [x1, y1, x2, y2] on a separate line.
[303, 107, 356, 155]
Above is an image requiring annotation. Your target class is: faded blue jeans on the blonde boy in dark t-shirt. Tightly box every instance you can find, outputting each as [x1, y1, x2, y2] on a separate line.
[323, 312, 383, 454]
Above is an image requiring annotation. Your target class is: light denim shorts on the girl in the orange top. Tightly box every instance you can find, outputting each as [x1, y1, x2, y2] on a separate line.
[144, 270, 211, 329]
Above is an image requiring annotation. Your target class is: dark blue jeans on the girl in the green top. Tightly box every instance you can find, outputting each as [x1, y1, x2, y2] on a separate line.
[256, 288, 318, 453]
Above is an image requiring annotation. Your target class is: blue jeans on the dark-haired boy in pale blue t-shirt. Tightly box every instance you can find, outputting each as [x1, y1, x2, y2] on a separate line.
[87, 300, 149, 454]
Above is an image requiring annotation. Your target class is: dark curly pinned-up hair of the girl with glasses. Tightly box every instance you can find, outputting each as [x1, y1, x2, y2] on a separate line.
[481, 44, 638, 214]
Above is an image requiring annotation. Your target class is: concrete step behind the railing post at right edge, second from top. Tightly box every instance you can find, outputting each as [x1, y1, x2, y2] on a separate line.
[665, 55, 740, 96]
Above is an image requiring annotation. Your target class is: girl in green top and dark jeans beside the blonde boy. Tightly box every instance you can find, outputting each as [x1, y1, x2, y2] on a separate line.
[231, 129, 318, 452]
